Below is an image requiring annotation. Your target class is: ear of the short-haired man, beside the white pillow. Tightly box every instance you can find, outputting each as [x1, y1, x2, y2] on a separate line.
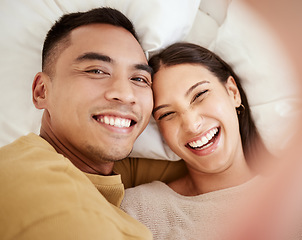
[32, 72, 50, 109]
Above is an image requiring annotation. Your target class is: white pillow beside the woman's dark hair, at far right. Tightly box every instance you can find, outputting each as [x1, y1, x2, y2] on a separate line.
[209, 0, 301, 154]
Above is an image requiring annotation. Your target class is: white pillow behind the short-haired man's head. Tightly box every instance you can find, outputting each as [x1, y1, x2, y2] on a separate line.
[0, 0, 200, 161]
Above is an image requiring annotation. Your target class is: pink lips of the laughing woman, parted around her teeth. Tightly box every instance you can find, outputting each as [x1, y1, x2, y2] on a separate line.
[186, 127, 221, 156]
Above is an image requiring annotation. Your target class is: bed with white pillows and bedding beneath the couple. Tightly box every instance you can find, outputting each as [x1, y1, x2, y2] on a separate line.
[0, 0, 300, 161]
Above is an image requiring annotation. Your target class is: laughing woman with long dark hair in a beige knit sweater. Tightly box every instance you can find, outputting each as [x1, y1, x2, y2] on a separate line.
[122, 43, 266, 240]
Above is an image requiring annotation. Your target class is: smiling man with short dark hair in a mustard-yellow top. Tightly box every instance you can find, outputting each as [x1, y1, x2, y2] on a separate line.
[0, 8, 153, 240]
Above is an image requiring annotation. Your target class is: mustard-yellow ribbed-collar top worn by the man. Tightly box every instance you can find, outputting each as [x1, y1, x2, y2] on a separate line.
[0, 134, 152, 240]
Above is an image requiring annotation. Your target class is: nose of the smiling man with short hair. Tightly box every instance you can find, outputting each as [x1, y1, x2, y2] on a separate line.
[105, 76, 136, 104]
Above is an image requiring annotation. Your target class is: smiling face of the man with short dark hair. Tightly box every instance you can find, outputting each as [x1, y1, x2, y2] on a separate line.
[46, 24, 153, 164]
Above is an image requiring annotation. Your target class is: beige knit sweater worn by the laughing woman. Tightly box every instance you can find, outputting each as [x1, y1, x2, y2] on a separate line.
[121, 180, 254, 240]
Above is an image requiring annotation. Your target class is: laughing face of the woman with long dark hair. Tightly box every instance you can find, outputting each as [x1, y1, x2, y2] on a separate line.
[153, 64, 244, 173]
